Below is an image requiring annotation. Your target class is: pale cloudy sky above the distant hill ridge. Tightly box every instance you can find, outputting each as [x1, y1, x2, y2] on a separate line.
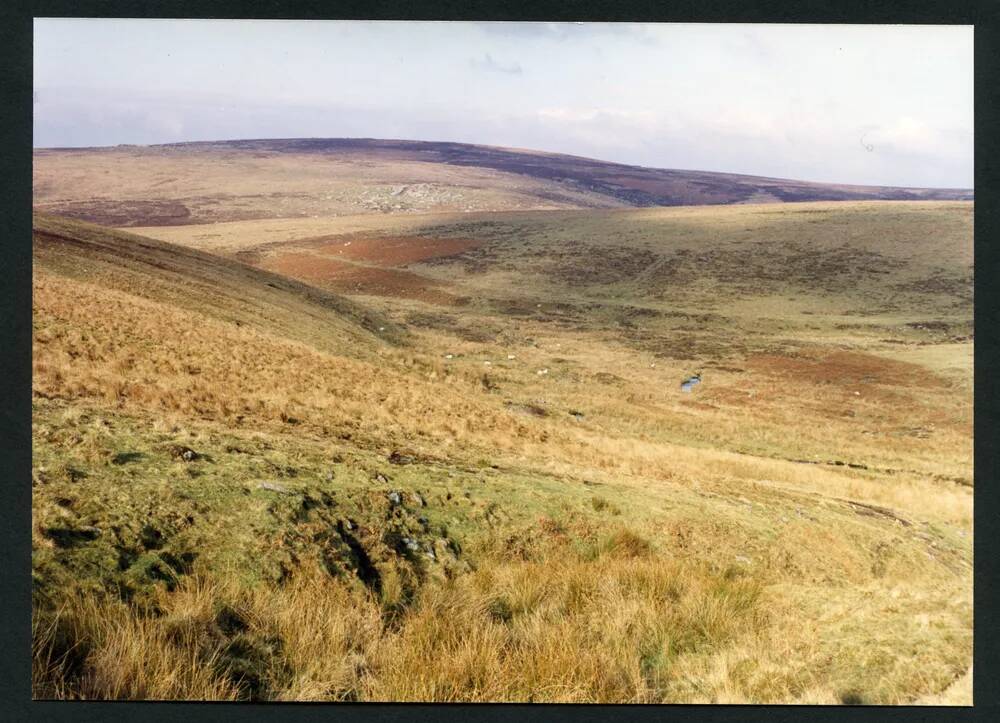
[34, 18, 973, 188]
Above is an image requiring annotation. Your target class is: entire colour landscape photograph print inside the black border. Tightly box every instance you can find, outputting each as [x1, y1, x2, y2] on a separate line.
[29, 17, 968, 713]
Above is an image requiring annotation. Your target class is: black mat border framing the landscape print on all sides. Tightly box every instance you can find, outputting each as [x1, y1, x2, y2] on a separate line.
[0, 0, 1000, 721]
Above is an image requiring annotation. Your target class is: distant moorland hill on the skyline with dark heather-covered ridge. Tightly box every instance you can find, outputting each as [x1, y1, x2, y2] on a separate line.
[34, 138, 973, 227]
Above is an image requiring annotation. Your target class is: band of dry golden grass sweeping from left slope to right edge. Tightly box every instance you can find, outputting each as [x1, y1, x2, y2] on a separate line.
[33, 264, 971, 523]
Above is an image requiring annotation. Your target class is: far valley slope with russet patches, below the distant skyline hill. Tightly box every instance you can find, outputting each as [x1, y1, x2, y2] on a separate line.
[143, 203, 972, 483]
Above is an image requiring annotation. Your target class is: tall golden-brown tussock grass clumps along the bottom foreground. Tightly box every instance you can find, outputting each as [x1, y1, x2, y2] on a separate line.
[34, 540, 765, 702]
